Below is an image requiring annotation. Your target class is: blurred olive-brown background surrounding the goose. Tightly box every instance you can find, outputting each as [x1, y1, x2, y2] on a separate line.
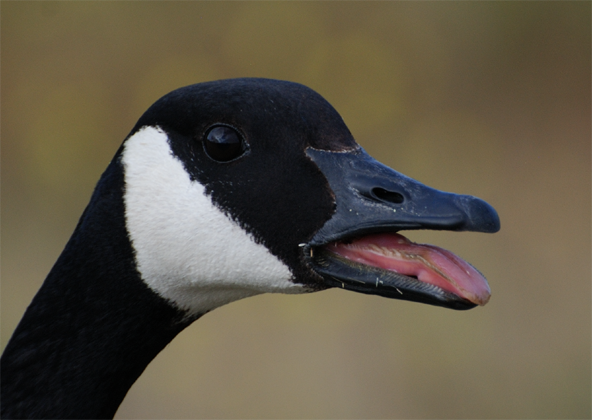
[1, 2, 591, 418]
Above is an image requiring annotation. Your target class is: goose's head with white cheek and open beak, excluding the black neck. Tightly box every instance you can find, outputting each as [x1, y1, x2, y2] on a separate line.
[120, 79, 499, 314]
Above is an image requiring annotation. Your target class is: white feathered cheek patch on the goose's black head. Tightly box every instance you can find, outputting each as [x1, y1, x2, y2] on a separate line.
[122, 127, 306, 313]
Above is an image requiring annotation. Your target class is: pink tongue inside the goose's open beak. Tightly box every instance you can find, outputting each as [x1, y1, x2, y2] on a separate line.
[328, 233, 491, 305]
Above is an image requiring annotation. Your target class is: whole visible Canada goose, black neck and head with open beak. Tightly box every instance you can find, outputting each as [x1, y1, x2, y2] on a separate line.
[1, 79, 499, 418]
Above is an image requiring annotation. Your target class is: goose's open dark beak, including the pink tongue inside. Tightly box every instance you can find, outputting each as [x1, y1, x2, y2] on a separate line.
[304, 148, 500, 309]
